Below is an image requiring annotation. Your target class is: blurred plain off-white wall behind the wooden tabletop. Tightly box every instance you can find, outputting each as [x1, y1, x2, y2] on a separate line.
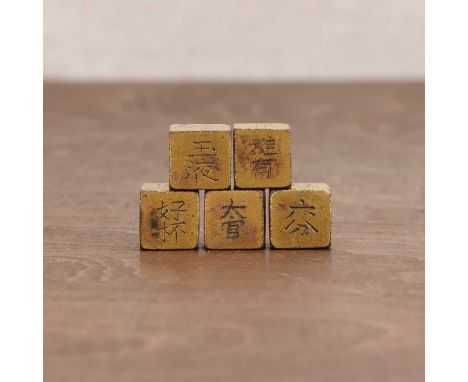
[44, 0, 424, 82]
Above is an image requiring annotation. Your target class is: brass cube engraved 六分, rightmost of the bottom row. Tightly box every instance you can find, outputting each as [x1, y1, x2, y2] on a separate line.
[270, 183, 331, 248]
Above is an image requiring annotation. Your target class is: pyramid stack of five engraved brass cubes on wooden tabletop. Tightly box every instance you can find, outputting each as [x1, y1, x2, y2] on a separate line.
[140, 123, 331, 250]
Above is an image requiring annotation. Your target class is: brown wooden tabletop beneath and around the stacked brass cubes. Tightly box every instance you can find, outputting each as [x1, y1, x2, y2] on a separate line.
[44, 84, 424, 382]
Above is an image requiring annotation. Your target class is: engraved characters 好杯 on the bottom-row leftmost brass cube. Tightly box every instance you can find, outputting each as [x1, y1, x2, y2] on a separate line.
[150, 200, 187, 243]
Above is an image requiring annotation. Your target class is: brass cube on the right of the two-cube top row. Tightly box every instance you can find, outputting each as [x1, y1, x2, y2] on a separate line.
[234, 123, 291, 188]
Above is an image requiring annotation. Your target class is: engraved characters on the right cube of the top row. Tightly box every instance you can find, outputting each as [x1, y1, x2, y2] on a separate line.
[250, 136, 278, 179]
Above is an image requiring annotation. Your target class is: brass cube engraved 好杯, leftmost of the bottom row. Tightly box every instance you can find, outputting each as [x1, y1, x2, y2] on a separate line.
[140, 183, 199, 250]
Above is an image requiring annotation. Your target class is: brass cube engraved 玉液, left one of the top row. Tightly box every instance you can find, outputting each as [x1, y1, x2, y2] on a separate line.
[169, 124, 231, 190]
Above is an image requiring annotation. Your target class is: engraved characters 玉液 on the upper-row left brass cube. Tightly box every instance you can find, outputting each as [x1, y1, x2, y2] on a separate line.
[184, 140, 220, 183]
